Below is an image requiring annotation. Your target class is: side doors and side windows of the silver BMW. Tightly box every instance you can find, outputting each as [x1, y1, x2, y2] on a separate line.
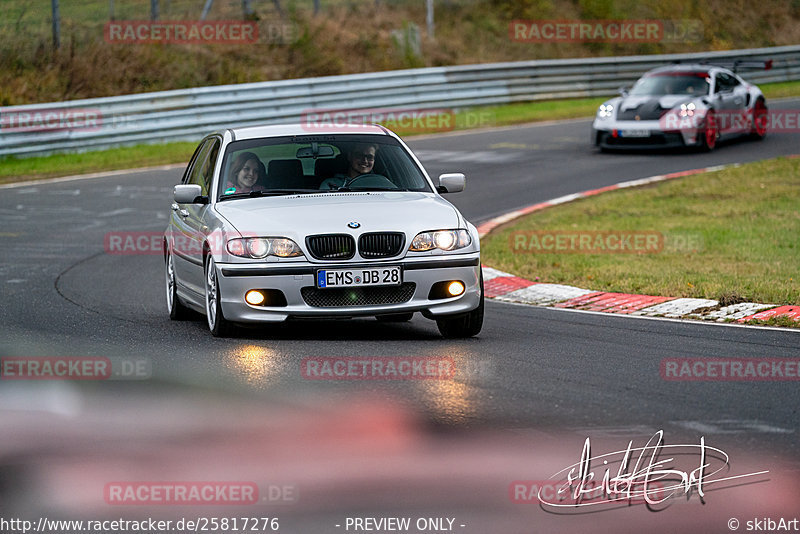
[172, 137, 221, 299]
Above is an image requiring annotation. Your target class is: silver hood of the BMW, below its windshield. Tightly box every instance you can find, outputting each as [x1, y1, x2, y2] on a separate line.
[216, 191, 466, 237]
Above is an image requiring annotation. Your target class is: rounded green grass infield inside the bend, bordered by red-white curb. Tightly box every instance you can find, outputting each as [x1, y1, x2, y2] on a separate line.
[481, 158, 800, 305]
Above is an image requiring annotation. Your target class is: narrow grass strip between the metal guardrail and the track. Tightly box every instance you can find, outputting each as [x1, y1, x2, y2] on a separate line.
[0, 81, 800, 184]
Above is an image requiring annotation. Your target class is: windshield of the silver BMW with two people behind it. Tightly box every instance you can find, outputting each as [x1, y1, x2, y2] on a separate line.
[217, 134, 431, 200]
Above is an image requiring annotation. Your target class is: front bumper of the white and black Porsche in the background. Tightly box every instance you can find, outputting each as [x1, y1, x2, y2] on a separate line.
[592, 119, 700, 149]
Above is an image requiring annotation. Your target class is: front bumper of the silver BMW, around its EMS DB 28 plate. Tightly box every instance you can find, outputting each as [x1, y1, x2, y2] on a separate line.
[217, 252, 480, 323]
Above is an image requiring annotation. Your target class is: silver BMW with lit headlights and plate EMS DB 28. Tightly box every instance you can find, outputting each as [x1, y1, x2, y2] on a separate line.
[164, 125, 484, 337]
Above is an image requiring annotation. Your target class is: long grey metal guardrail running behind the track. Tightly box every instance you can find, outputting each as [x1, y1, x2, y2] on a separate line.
[0, 46, 800, 156]
